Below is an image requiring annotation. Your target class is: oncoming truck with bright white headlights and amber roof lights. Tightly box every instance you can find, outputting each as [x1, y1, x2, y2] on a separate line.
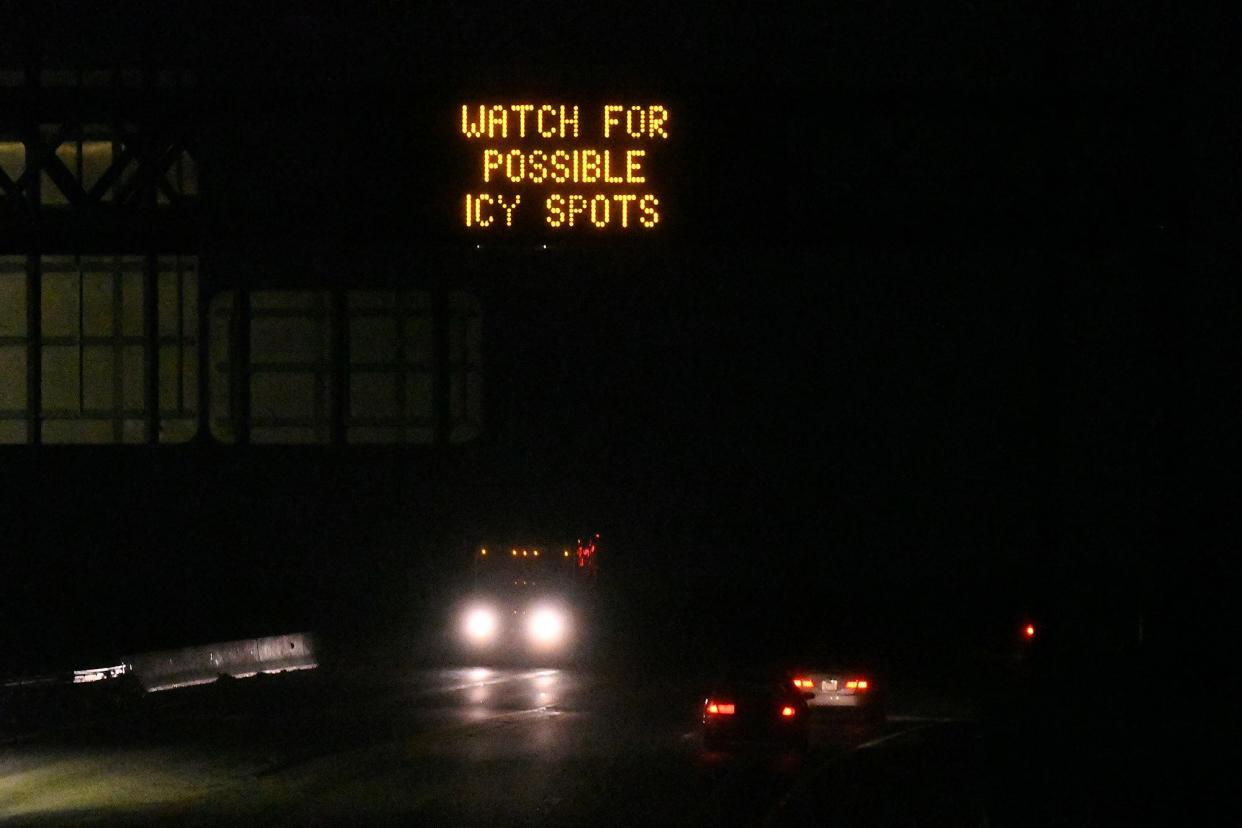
[456, 535, 599, 664]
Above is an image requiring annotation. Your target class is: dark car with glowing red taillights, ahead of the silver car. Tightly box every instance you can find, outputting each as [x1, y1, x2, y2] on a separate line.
[703, 678, 810, 750]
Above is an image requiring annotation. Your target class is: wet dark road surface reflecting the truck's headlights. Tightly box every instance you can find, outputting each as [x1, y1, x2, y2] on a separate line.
[0, 668, 925, 826]
